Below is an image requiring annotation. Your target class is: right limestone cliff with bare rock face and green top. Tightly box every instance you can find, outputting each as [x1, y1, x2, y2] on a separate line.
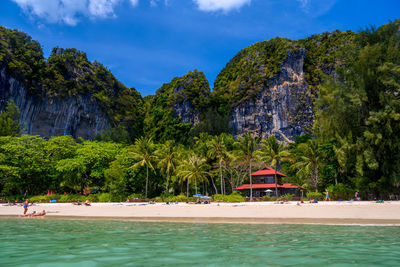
[213, 31, 354, 142]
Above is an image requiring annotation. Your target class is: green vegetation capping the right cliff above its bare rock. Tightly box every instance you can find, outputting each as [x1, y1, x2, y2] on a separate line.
[212, 30, 355, 110]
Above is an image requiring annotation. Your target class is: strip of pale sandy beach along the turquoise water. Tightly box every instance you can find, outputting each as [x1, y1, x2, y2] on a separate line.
[0, 201, 400, 225]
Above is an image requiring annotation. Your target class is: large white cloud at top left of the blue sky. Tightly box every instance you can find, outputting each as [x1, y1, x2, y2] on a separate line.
[12, 0, 139, 26]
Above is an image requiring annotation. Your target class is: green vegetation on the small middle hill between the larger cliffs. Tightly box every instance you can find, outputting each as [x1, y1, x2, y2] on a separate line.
[144, 70, 210, 143]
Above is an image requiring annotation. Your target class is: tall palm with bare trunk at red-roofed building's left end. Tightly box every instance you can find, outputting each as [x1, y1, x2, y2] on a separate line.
[236, 133, 259, 201]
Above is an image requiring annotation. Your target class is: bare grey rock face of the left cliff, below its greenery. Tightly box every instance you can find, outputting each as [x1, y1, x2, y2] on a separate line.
[0, 69, 110, 139]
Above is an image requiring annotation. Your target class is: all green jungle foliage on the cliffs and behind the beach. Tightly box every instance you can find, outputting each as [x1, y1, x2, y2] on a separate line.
[0, 20, 400, 201]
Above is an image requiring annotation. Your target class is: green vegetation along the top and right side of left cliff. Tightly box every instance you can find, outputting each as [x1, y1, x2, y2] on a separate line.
[0, 27, 144, 141]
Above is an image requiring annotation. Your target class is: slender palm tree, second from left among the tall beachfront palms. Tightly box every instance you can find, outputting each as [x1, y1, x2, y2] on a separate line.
[155, 140, 178, 193]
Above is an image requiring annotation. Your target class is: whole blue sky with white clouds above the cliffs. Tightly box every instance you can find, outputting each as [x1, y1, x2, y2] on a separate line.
[0, 0, 400, 96]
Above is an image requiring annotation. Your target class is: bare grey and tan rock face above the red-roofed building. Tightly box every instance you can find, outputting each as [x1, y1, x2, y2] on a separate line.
[230, 49, 313, 141]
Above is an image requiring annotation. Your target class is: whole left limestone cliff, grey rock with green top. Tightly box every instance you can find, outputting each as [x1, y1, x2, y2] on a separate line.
[0, 26, 144, 140]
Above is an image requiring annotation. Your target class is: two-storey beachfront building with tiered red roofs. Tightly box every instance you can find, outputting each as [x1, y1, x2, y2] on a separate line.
[235, 167, 304, 197]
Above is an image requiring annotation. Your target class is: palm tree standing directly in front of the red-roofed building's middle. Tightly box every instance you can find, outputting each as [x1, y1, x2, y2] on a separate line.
[257, 135, 290, 196]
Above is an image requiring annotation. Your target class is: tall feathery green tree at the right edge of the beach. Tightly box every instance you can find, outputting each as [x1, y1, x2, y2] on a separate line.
[314, 20, 400, 196]
